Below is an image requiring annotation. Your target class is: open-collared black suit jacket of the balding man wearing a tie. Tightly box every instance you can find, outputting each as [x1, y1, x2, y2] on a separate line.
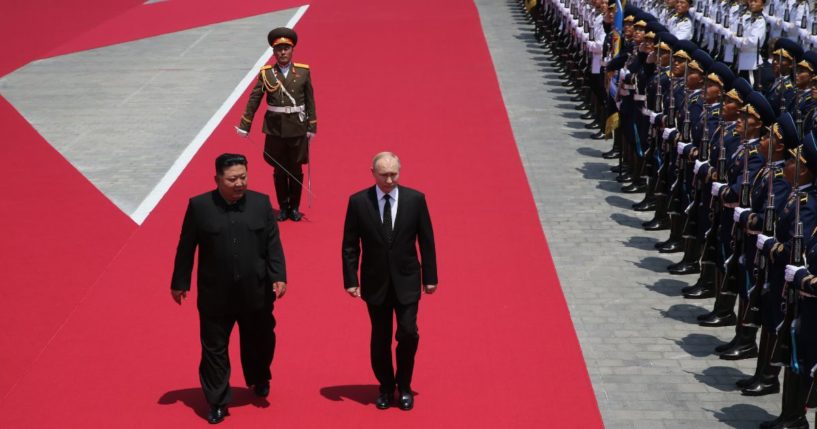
[342, 186, 437, 305]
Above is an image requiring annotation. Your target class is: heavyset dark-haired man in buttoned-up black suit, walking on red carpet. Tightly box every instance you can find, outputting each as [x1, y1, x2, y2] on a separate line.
[170, 153, 286, 423]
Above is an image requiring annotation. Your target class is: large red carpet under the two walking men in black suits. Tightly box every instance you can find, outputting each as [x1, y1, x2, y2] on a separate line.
[0, 0, 602, 428]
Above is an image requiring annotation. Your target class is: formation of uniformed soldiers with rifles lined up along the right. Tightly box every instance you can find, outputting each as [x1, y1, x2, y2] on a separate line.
[524, 0, 817, 428]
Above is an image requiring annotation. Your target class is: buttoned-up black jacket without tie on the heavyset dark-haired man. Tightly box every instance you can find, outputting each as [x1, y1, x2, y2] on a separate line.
[170, 190, 286, 315]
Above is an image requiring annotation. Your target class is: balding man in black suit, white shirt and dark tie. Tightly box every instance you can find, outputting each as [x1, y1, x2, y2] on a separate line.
[342, 152, 437, 410]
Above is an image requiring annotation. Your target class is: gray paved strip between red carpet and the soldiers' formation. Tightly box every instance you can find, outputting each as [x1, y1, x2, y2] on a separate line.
[475, 0, 796, 429]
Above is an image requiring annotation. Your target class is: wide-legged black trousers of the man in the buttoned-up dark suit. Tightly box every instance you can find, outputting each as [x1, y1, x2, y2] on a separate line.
[199, 307, 275, 406]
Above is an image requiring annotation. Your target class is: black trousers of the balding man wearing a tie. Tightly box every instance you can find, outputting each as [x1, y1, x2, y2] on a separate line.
[367, 286, 420, 393]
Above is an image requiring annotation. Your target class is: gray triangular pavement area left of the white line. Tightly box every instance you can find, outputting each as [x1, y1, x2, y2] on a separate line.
[0, 5, 297, 222]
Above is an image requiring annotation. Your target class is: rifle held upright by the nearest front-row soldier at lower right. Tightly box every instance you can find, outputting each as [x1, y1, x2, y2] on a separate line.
[770, 146, 803, 368]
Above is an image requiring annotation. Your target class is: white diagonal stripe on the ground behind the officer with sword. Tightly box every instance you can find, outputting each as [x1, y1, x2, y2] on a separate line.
[130, 5, 309, 225]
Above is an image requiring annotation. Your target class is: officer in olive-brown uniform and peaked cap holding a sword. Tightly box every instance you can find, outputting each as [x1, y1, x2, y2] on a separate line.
[236, 27, 318, 222]
